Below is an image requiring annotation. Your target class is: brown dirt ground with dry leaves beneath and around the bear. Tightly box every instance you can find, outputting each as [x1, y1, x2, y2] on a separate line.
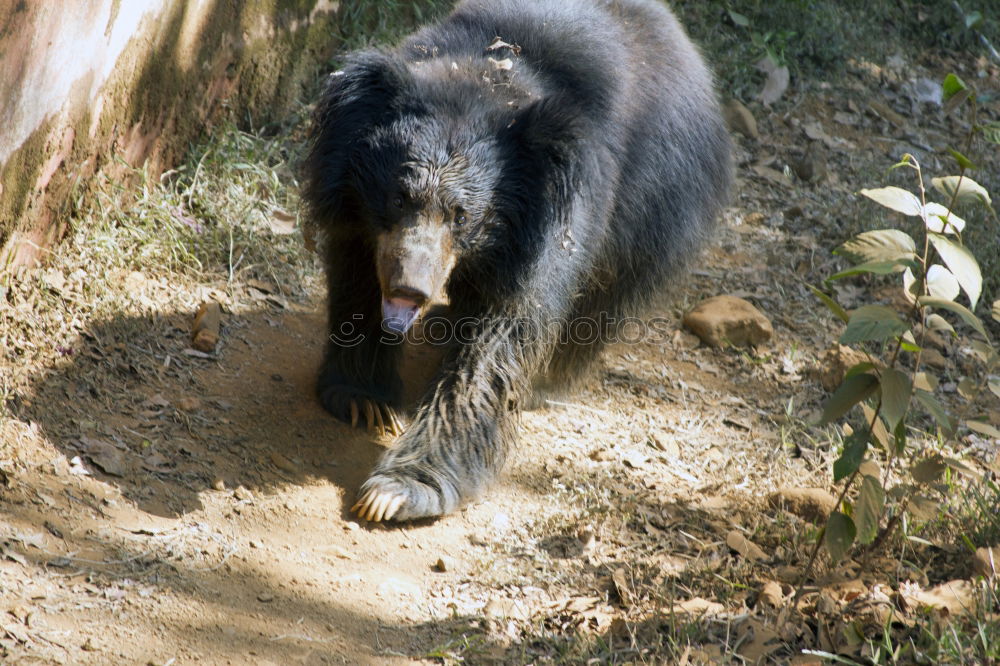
[0, 41, 1000, 665]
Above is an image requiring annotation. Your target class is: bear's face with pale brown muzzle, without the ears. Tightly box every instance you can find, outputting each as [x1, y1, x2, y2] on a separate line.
[351, 116, 508, 333]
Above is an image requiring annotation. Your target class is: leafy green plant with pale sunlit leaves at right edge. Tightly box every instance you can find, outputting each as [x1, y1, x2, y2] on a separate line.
[803, 75, 1000, 580]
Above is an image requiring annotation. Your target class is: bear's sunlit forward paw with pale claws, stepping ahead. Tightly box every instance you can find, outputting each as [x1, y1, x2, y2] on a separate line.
[351, 468, 459, 523]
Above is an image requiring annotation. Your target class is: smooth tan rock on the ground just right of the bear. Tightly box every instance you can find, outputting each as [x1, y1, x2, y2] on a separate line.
[684, 295, 774, 347]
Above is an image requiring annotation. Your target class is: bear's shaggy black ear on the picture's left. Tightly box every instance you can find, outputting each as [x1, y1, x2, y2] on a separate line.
[303, 51, 412, 224]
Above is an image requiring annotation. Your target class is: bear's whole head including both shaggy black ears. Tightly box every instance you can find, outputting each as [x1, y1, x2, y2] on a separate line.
[305, 52, 577, 333]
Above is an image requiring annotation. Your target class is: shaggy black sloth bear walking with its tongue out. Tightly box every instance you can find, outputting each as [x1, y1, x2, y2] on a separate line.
[302, 0, 732, 522]
